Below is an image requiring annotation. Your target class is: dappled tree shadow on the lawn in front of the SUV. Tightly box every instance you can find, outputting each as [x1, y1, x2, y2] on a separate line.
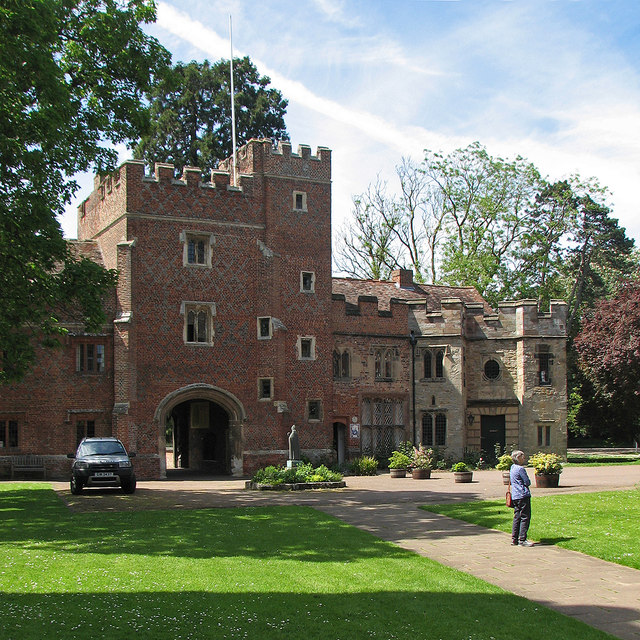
[0, 488, 408, 562]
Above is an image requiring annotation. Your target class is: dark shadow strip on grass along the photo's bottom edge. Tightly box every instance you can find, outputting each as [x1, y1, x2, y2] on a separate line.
[2, 588, 620, 640]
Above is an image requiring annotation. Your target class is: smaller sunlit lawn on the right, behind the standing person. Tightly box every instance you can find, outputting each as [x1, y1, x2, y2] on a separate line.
[422, 490, 640, 569]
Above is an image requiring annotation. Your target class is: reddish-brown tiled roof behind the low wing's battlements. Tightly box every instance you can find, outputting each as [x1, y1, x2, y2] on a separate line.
[333, 278, 491, 313]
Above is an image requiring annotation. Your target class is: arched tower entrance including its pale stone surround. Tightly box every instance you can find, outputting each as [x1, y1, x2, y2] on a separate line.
[154, 384, 246, 476]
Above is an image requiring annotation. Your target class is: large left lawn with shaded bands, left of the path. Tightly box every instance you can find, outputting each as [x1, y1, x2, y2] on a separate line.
[0, 483, 611, 640]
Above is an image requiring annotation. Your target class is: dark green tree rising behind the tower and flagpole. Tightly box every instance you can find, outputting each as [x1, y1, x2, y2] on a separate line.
[135, 57, 289, 170]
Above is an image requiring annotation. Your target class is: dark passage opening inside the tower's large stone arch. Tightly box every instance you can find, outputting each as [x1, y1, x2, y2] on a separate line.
[166, 400, 231, 475]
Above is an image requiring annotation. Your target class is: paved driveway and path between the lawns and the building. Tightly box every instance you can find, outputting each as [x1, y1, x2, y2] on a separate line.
[53, 466, 640, 640]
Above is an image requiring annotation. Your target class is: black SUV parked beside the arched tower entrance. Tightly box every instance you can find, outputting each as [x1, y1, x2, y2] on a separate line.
[67, 438, 136, 495]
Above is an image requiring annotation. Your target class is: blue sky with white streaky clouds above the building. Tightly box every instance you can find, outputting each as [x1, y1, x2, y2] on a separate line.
[62, 0, 640, 250]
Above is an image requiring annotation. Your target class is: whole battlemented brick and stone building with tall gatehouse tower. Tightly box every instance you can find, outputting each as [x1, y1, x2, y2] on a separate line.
[0, 140, 566, 478]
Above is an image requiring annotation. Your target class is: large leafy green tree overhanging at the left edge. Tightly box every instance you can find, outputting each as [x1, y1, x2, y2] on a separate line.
[0, 0, 170, 382]
